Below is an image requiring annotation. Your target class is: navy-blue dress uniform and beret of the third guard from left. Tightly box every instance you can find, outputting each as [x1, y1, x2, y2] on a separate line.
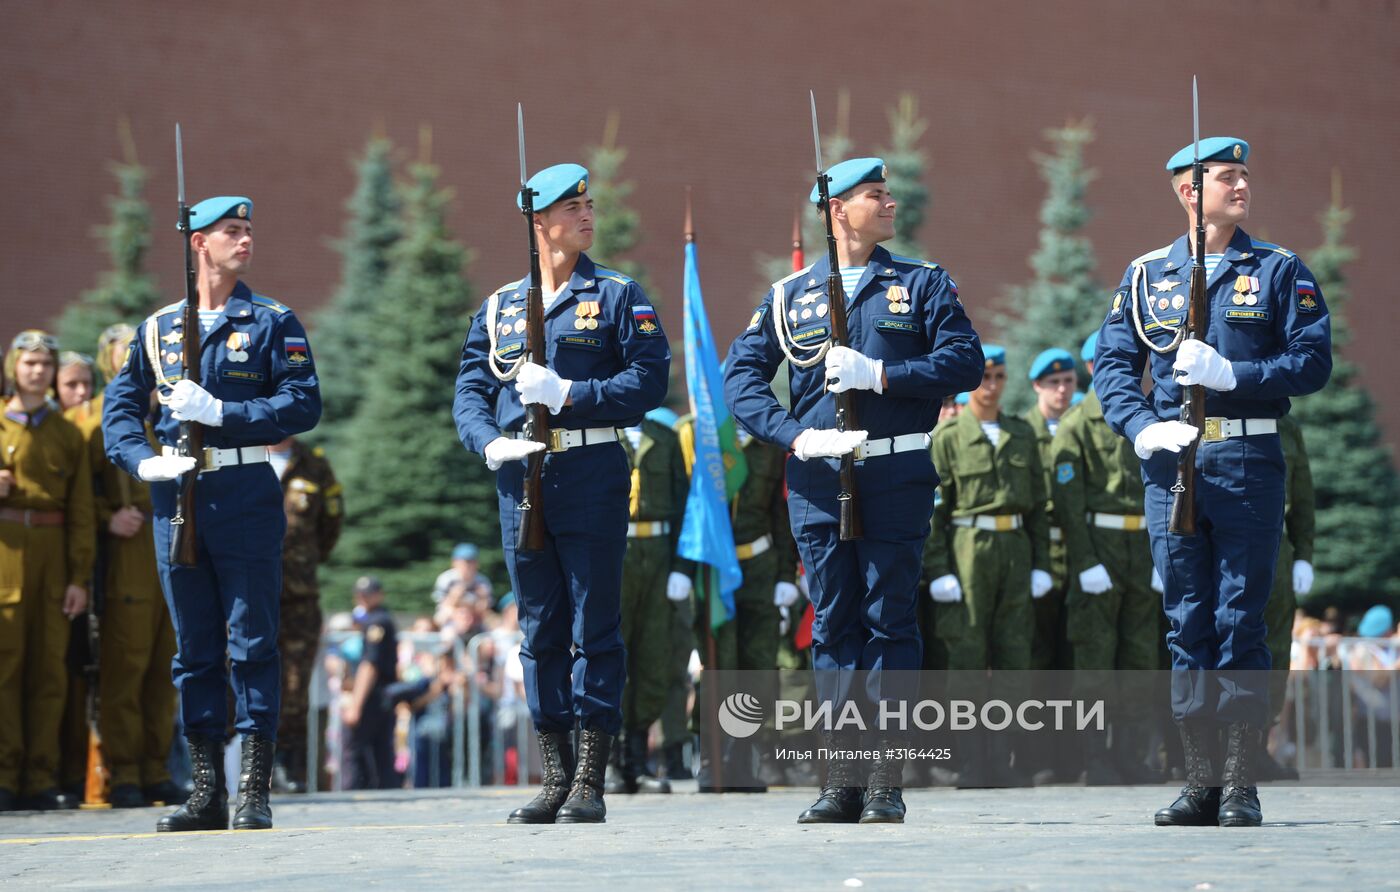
[724, 158, 983, 716]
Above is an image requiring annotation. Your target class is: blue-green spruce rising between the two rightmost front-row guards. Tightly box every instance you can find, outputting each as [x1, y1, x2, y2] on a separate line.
[994, 120, 1107, 413]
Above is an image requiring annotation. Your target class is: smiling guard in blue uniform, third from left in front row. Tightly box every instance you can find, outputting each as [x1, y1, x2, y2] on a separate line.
[725, 158, 983, 823]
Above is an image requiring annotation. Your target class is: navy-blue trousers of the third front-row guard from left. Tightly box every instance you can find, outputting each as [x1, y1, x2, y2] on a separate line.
[787, 450, 938, 703]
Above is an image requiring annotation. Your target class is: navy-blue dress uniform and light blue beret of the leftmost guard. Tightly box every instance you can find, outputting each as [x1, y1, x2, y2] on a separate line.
[102, 196, 321, 829]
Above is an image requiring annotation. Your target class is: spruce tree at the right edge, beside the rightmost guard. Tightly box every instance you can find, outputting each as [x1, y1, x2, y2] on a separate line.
[1292, 183, 1400, 609]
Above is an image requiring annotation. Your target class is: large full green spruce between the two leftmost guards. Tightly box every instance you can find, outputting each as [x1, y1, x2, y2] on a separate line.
[326, 161, 504, 611]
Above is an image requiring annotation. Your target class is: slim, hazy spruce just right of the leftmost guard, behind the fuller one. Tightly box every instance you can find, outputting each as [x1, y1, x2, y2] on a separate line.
[311, 136, 403, 457]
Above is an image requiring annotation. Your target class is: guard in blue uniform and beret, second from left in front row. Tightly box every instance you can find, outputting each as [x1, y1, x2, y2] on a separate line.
[454, 164, 671, 823]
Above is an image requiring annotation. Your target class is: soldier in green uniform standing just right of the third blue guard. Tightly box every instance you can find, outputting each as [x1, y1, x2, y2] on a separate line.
[924, 344, 1053, 786]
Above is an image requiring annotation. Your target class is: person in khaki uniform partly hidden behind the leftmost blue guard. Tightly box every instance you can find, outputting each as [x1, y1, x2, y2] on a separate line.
[59, 325, 188, 808]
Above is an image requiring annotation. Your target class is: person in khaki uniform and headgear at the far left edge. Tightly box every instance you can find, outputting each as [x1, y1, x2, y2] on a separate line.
[0, 330, 95, 809]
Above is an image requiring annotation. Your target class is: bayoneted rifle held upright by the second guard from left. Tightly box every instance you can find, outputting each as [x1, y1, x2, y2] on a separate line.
[515, 104, 550, 552]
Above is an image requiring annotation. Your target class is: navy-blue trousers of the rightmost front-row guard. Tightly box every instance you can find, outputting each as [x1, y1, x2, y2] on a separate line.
[1142, 434, 1284, 727]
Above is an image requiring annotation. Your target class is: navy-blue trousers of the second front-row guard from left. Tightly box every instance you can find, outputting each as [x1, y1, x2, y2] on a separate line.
[496, 442, 631, 734]
